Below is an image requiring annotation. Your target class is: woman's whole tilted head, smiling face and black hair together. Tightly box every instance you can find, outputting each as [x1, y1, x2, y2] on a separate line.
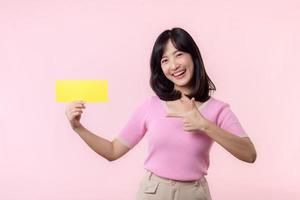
[150, 28, 216, 102]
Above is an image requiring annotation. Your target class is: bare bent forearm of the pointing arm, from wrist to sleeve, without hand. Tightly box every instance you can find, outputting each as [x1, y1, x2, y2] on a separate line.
[202, 120, 256, 163]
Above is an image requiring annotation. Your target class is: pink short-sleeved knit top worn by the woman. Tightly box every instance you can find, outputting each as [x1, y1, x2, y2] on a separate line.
[117, 96, 247, 181]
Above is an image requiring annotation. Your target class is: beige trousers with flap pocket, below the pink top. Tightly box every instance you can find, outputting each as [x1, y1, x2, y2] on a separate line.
[137, 171, 211, 200]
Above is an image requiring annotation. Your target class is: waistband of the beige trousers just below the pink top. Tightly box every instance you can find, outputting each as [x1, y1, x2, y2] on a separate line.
[145, 170, 206, 186]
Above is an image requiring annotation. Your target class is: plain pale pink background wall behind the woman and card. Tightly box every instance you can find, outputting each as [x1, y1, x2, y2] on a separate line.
[0, 0, 300, 200]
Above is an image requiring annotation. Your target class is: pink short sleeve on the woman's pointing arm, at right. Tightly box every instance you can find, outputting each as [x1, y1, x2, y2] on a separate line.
[217, 103, 248, 137]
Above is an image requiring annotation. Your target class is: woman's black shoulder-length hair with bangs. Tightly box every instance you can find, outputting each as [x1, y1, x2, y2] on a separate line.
[150, 27, 216, 102]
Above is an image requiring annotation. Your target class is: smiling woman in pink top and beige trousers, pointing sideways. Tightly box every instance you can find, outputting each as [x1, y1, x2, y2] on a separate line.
[66, 28, 256, 200]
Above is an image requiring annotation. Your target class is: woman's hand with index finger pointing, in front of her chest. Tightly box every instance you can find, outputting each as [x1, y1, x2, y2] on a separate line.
[167, 97, 207, 131]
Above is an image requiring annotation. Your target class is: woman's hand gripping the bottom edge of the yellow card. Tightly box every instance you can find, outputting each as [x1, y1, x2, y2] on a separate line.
[65, 101, 85, 129]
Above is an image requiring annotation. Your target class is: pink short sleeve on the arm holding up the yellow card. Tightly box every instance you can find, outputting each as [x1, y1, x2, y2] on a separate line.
[117, 99, 150, 148]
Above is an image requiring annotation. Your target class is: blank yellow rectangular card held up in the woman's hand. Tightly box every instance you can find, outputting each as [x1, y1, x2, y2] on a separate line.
[56, 80, 108, 102]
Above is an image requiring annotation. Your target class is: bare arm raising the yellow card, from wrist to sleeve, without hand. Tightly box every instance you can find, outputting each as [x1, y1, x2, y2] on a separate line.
[73, 125, 130, 161]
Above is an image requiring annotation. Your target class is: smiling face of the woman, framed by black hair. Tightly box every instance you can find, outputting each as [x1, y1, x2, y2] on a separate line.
[160, 39, 194, 94]
